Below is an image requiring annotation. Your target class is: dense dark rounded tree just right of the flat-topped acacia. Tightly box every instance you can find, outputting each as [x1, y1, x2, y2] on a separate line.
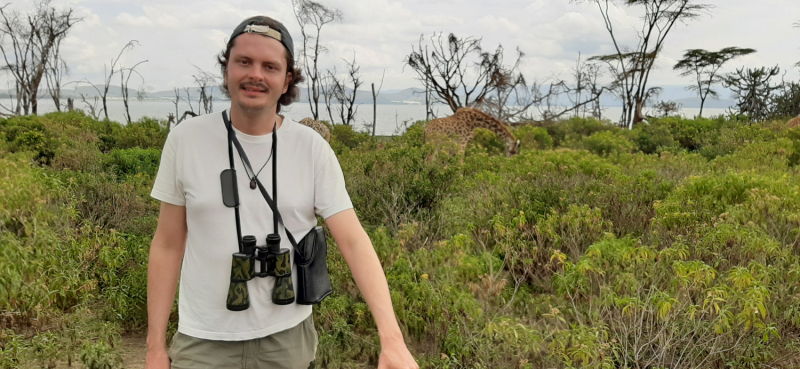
[722, 65, 781, 122]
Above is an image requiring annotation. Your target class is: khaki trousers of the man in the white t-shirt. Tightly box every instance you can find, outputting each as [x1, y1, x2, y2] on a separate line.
[169, 316, 318, 369]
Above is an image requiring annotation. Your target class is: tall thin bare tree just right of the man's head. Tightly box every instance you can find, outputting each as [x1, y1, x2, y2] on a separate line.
[292, 0, 342, 120]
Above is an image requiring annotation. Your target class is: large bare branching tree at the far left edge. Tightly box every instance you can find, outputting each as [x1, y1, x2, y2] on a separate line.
[0, 0, 81, 115]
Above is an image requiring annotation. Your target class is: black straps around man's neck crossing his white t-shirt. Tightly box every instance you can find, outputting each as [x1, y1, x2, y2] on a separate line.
[222, 111, 297, 252]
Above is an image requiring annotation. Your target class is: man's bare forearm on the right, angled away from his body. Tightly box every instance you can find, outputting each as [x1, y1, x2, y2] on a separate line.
[339, 233, 403, 345]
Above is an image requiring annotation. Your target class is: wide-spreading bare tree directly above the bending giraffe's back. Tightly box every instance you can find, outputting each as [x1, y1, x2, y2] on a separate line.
[404, 33, 503, 113]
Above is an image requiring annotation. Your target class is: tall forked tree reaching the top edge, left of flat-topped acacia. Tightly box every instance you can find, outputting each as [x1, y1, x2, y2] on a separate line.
[571, 0, 710, 128]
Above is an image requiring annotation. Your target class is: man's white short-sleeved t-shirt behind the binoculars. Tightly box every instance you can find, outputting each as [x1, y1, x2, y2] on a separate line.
[151, 113, 353, 341]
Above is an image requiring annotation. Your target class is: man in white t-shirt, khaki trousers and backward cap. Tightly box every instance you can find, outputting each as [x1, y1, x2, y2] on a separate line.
[145, 17, 418, 369]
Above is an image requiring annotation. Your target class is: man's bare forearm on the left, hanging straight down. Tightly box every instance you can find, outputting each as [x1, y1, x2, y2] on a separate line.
[147, 238, 184, 349]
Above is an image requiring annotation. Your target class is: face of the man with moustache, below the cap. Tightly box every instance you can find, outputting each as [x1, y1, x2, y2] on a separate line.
[224, 33, 291, 112]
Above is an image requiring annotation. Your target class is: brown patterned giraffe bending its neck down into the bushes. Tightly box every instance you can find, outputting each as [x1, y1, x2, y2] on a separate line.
[425, 108, 519, 156]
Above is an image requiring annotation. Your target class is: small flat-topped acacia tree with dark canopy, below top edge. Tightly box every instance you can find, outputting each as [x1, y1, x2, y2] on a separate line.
[673, 47, 756, 117]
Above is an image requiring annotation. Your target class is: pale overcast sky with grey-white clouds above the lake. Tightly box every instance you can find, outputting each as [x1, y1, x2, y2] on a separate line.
[0, 0, 800, 95]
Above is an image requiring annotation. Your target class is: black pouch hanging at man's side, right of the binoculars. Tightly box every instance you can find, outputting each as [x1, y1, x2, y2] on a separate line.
[294, 226, 333, 305]
